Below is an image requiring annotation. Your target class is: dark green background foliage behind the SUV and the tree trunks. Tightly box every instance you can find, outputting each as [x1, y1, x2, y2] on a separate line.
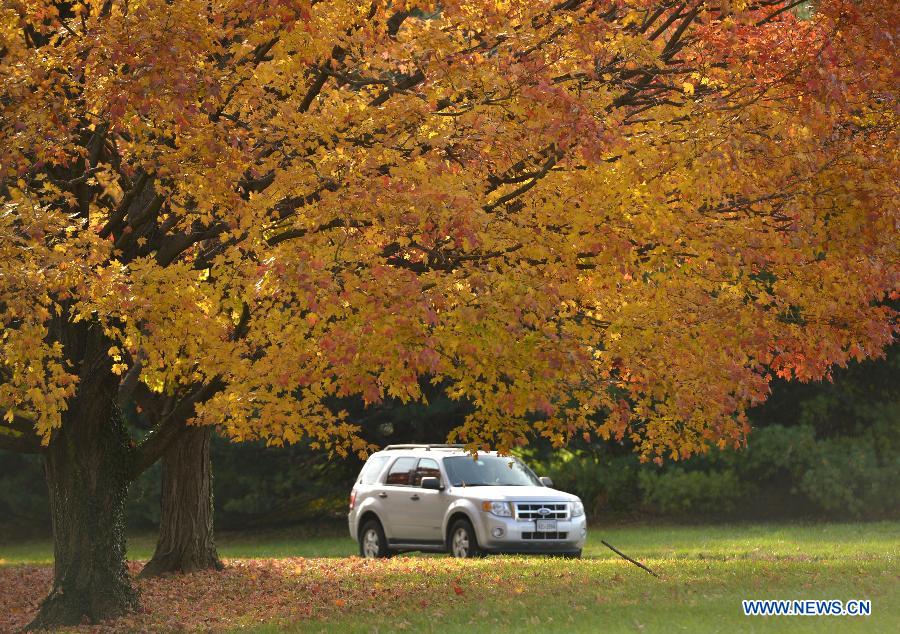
[0, 346, 900, 537]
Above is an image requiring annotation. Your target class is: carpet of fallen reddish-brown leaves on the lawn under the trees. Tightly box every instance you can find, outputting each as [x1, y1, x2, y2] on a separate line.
[0, 556, 544, 632]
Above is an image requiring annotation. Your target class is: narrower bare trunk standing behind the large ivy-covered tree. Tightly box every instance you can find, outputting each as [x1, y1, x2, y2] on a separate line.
[141, 427, 223, 577]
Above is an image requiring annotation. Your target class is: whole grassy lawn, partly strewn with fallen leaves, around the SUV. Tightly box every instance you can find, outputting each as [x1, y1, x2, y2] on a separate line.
[0, 522, 900, 632]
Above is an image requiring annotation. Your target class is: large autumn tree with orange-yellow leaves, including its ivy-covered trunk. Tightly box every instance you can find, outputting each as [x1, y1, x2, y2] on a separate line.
[0, 0, 898, 625]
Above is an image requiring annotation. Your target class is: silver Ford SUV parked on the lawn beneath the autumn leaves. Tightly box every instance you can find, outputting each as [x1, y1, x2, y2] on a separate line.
[348, 445, 587, 558]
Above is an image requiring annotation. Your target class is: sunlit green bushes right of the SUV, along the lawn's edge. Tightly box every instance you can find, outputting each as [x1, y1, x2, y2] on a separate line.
[526, 425, 900, 520]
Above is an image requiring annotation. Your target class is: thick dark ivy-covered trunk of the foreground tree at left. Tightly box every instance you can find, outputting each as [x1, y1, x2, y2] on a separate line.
[29, 382, 137, 628]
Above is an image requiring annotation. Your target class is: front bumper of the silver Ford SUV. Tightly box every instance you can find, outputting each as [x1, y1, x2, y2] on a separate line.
[476, 514, 587, 553]
